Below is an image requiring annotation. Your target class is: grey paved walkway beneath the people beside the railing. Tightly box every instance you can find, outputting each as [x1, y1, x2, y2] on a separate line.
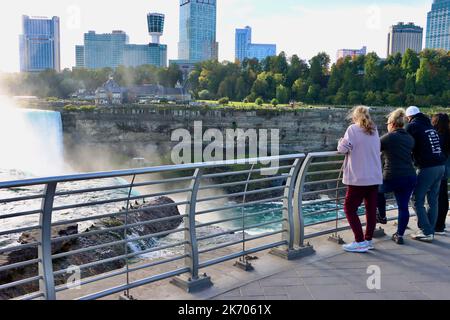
[214, 221, 450, 300]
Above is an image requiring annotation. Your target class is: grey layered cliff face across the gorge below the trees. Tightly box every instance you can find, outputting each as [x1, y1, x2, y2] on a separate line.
[62, 107, 390, 160]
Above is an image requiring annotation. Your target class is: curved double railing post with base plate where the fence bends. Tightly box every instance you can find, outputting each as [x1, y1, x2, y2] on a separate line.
[271, 159, 314, 260]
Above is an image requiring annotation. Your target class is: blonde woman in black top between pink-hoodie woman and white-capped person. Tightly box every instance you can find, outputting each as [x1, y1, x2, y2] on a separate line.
[377, 109, 417, 245]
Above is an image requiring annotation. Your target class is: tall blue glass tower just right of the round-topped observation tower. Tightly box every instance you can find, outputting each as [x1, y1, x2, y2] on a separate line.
[178, 0, 219, 63]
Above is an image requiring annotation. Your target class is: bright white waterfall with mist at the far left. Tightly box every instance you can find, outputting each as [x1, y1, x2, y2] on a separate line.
[0, 97, 64, 176]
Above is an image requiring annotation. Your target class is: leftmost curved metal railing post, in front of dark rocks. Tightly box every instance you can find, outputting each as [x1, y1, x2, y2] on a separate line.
[38, 182, 57, 300]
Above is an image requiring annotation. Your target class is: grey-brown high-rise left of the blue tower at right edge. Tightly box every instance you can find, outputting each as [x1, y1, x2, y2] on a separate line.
[387, 22, 423, 56]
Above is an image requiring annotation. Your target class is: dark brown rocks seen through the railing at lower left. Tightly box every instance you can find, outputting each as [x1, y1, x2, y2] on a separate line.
[0, 197, 183, 299]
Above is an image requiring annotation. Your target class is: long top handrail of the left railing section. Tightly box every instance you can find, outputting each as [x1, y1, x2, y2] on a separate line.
[0, 154, 305, 189]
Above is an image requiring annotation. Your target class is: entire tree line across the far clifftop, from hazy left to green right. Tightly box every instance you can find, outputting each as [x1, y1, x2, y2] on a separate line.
[0, 49, 450, 106]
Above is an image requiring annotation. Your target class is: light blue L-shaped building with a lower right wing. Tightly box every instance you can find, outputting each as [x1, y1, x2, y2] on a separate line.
[235, 26, 277, 61]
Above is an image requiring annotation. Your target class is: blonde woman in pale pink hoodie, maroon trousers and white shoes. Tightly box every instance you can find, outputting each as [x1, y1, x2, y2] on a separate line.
[338, 106, 383, 252]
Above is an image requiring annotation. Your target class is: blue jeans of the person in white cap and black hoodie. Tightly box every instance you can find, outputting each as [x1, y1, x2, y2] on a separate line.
[413, 166, 445, 235]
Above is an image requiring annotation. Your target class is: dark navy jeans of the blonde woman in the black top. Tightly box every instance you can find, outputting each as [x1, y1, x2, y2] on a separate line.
[378, 176, 417, 236]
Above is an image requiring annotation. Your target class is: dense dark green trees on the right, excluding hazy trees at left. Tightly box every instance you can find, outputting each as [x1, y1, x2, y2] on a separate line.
[189, 49, 450, 106]
